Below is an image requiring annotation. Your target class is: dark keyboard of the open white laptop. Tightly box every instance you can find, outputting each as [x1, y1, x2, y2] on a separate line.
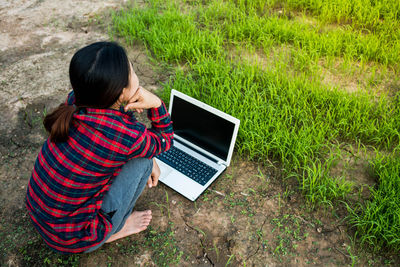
[156, 146, 217, 185]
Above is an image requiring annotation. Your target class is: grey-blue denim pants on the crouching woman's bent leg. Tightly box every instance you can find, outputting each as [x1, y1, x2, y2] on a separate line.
[85, 158, 153, 253]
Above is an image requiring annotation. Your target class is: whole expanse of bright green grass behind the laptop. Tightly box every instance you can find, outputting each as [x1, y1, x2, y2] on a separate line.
[112, 0, 400, 253]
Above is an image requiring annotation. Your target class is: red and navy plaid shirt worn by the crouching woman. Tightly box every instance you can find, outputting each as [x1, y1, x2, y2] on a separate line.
[26, 93, 173, 253]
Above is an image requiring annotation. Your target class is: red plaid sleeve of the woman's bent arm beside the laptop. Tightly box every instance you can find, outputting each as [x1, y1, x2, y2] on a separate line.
[129, 102, 174, 159]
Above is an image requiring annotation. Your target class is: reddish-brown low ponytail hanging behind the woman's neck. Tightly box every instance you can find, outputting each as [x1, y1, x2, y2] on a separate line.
[43, 104, 76, 142]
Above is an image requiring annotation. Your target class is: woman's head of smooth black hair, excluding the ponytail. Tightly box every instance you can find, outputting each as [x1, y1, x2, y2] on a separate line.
[69, 42, 130, 108]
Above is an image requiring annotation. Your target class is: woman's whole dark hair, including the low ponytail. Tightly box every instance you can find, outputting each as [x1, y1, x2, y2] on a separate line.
[43, 42, 130, 142]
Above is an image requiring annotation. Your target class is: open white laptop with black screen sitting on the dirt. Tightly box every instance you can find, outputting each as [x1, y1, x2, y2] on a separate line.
[156, 89, 240, 201]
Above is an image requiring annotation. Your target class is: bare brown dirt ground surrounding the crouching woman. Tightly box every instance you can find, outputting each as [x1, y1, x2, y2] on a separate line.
[0, 0, 394, 266]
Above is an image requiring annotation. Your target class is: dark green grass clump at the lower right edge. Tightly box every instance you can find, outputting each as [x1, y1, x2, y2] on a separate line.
[350, 152, 400, 251]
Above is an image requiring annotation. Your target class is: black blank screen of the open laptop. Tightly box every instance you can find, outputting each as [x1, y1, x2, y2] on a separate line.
[171, 95, 235, 160]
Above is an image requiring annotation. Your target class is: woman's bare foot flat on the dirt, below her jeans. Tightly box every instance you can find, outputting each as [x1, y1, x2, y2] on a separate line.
[106, 210, 151, 243]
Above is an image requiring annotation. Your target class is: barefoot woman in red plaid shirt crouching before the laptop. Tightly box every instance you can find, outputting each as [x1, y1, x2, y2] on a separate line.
[26, 42, 173, 253]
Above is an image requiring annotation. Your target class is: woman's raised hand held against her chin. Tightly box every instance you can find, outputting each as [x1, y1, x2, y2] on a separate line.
[125, 86, 161, 113]
